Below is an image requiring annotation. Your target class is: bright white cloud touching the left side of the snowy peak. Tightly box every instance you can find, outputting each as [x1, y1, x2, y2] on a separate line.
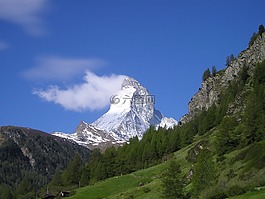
[33, 72, 126, 111]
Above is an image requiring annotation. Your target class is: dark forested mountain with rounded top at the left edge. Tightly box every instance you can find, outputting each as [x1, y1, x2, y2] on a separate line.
[0, 126, 90, 192]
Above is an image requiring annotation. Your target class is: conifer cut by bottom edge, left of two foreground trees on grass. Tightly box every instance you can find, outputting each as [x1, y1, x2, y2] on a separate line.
[162, 160, 184, 199]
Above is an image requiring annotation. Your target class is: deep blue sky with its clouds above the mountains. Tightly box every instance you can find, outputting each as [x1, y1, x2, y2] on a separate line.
[0, 0, 265, 133]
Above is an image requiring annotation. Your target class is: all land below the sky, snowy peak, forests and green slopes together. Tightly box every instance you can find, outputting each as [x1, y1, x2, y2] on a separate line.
[0, 25, 265, 199]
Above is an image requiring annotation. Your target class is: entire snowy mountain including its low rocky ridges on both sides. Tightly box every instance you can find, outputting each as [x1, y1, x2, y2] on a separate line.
[53, 77, 177, 148]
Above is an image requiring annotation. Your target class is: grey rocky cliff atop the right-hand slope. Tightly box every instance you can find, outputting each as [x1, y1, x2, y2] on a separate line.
[180, 33, 265, 123]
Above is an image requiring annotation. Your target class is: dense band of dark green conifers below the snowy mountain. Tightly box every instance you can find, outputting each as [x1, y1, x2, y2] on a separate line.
[47, 126, 192, 191]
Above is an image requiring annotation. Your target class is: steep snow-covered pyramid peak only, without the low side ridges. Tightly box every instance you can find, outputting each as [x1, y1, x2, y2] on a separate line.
[92, 77, 162, 140]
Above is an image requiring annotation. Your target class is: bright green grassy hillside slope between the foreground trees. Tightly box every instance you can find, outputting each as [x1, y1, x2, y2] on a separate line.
[69, 129, 265, 199]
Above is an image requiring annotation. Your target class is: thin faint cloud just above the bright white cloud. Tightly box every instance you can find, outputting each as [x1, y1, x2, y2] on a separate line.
[22, 57, 104, 80]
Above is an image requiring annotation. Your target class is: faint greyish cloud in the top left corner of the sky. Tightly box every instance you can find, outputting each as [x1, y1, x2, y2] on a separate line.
[0, 0, 48, 35]
